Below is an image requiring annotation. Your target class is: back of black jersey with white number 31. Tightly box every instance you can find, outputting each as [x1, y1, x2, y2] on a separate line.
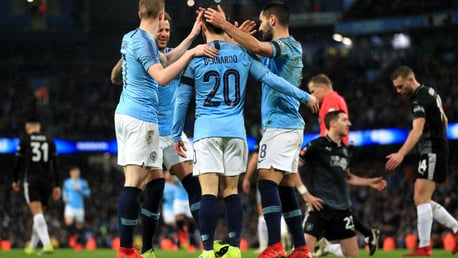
[16, 133, 57, 182]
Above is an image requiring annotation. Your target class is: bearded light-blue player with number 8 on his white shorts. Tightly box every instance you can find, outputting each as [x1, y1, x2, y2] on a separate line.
[204, 3, 319, 258]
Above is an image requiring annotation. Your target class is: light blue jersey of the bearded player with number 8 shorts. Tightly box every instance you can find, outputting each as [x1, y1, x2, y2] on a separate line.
[261, 36, 305, 130]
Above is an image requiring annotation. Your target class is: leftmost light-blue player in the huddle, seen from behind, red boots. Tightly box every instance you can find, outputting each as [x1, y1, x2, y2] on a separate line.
[112, 0, 217, 258]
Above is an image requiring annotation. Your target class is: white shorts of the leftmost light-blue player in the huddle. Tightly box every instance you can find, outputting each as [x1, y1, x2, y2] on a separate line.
[115, 114, 162, 169]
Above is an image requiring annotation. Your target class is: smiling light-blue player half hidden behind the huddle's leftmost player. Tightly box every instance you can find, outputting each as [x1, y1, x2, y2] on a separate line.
[111, 10, 206, 253]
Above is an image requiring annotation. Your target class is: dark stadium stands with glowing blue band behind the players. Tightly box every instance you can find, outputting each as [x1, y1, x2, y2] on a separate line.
[0, 0, 458, 251]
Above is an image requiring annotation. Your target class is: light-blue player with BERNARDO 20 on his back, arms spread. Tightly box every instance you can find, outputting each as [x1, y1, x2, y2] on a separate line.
[172, 11, 313, 258]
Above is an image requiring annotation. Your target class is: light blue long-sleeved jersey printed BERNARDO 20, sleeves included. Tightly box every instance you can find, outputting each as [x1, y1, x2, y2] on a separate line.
[172, 41, 310, 142]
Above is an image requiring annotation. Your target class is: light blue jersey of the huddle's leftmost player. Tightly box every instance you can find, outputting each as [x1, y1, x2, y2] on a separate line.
[115, 28, 159, 123]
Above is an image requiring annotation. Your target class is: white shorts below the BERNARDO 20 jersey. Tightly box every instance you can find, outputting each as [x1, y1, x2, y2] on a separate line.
[194, 137, 248, 176]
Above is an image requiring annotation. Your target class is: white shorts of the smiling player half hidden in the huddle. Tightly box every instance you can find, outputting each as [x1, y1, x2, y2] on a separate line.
[160, 133, 194, 171]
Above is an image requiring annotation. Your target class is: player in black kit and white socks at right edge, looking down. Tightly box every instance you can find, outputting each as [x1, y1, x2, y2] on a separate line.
[385, 66, 458, 256]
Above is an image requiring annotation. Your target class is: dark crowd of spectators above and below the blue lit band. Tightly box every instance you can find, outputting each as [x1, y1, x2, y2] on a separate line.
[0, 1, 458, 256]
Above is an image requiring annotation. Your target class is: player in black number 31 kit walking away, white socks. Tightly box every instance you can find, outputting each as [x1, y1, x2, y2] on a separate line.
[12, 118, 61, 254]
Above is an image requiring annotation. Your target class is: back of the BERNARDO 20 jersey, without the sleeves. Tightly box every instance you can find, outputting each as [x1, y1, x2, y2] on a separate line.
[184, 41, 253, 140]
